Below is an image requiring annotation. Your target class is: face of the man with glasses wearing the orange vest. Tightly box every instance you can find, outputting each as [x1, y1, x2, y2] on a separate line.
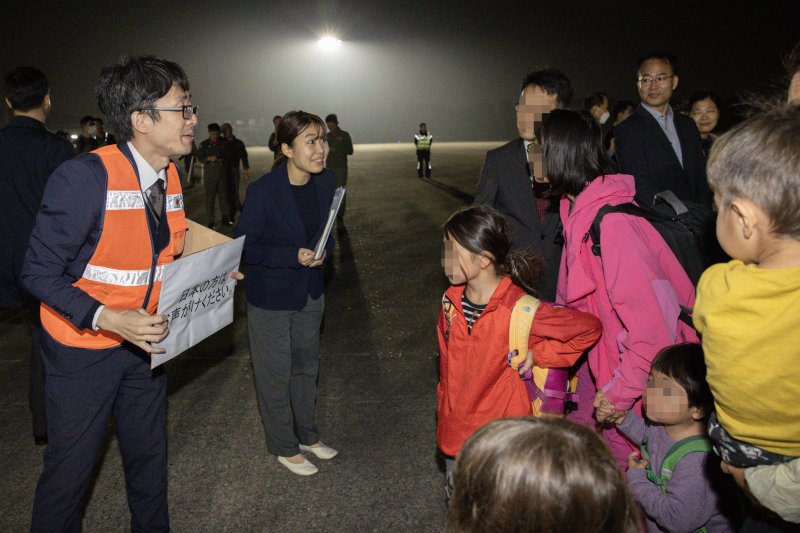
[136, 85, 197, 157]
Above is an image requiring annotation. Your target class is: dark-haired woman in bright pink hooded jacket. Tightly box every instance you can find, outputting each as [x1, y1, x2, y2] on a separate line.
[534, 109, 697, 470]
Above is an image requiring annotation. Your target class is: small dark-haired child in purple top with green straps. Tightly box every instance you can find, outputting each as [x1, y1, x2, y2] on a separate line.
[603, 343, 734, 533]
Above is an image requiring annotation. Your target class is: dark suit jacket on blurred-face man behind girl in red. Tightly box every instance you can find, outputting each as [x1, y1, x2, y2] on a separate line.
[475, 139, 564, 301]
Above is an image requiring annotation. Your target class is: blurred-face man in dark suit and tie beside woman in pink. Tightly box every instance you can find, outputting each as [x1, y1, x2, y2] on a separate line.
[475, 69, 573, 301]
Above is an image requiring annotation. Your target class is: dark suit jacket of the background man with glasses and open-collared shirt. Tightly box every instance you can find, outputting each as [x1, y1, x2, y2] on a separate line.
[615, 104, 711, 207]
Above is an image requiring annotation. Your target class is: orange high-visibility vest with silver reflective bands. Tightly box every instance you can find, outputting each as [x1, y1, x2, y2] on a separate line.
[40, 145, 188, 349]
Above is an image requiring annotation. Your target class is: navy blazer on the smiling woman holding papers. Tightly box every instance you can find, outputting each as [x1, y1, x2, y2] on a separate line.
[234, 163, 336, 311]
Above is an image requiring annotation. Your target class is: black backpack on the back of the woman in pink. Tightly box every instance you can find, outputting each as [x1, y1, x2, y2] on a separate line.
[585, 191, 726, 325]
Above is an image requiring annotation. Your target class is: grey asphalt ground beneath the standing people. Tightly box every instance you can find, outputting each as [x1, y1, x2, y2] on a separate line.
[0, 142, 500, 533]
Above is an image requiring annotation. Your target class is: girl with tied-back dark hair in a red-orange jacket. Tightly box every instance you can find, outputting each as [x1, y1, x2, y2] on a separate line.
[436, 206, 600, 495]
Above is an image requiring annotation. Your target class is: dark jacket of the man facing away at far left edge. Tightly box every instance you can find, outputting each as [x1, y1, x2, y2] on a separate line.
[0, 117, 72, 307]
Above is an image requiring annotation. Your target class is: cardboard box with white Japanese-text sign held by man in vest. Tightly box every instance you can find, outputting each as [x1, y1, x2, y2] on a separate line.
[150, 221, 244, 368]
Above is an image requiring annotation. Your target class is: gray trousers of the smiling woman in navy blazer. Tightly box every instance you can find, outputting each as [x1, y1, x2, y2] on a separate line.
[247, 295, 325, 457]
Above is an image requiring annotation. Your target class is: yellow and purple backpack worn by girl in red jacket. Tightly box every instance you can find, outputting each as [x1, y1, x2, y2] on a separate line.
[442, 294, 577, 416]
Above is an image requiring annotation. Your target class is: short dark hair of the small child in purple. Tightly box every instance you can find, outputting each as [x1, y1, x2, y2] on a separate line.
[650, 342, 714, 417]
